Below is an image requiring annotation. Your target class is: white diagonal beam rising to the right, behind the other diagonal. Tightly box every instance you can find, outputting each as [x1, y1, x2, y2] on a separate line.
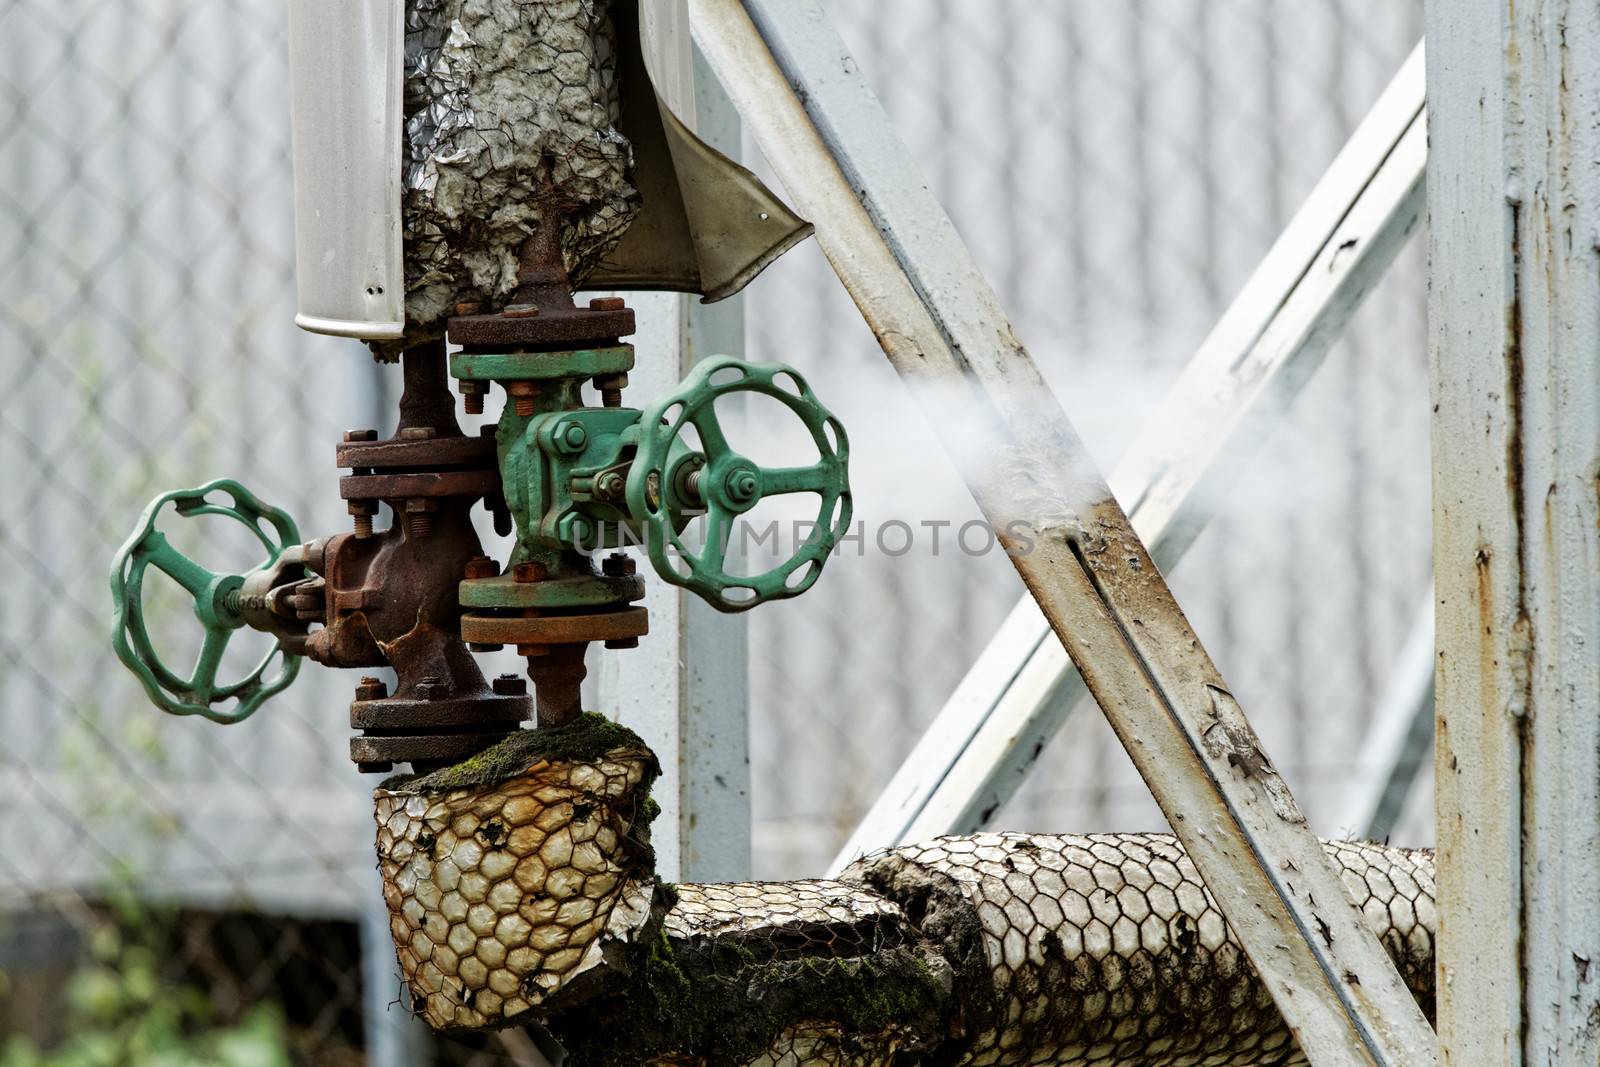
[832, 45, 1427, 872]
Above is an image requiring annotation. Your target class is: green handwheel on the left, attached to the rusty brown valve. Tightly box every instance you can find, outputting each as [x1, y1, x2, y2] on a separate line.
[110, 478, 301, 723]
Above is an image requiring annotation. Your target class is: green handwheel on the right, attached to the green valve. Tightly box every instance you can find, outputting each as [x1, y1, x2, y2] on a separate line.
[627, 355, 851, 611]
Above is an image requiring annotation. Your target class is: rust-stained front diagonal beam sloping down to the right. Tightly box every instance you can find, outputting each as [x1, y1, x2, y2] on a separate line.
[690, 0, 1437, 1067]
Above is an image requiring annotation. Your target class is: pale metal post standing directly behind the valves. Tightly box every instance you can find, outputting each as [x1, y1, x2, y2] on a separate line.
[598, 40, 750, 881]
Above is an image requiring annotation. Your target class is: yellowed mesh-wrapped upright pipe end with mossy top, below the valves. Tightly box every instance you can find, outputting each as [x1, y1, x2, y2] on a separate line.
[374, 715, 658, 1030]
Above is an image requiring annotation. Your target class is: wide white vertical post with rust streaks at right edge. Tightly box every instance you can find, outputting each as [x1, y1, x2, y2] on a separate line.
[1427, 0, 1600, 1067]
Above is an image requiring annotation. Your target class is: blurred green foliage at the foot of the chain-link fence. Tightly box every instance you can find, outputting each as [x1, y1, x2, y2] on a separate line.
[0, 901, 290, 1067]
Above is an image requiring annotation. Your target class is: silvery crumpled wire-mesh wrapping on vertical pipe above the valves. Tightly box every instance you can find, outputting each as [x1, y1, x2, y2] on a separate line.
[394, 0, 638, 350]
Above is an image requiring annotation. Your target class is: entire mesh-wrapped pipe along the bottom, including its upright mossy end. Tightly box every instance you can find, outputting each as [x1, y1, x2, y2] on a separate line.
[376, 729, 1435, 1067]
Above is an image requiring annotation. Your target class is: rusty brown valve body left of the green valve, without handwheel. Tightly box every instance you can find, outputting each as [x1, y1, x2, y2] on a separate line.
[316, 342, 530, 771]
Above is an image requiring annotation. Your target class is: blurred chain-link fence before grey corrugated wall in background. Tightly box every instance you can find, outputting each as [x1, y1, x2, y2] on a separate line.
[0, 0, 1429, 1067]
